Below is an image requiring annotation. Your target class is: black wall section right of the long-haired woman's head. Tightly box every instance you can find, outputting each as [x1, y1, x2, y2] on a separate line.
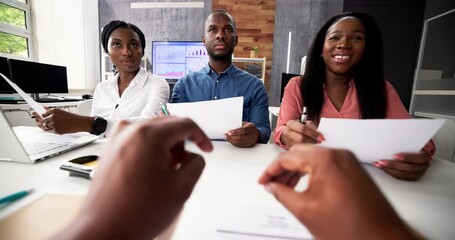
[344, 0, 430, 110]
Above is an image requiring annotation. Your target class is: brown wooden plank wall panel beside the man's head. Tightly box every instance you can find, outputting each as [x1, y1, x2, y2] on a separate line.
[212, 0, 276, 90]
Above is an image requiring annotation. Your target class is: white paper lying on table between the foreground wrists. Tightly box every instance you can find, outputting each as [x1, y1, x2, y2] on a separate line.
[172, 202, 314, 240]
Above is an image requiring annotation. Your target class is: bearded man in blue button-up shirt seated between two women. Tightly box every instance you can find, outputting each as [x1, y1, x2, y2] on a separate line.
[171, 10, 270, 147]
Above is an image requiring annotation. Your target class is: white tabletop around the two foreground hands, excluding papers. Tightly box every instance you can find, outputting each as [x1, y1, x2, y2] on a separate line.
[0, 140, 455, 239]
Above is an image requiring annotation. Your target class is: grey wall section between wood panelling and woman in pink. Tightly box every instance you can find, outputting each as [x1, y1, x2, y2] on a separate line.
[269, 0, 343, 106]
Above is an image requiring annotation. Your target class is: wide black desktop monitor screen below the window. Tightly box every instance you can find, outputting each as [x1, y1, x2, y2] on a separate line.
[8, 59, 68, 93]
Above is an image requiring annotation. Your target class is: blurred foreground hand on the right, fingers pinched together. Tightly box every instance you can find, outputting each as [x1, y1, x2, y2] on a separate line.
[259, 145, 412, 239]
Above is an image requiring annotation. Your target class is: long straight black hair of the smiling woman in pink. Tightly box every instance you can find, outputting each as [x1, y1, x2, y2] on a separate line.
[301, 12, 387, 122]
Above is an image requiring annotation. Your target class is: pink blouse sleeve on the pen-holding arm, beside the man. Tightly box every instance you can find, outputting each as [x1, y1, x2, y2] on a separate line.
[273, 76, 302, 148]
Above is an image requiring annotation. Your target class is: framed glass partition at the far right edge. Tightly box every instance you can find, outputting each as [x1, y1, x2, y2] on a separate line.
[411, 9, 455, 120]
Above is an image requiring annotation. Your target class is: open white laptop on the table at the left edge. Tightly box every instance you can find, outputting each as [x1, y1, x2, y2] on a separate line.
[0, 110, 98, 163]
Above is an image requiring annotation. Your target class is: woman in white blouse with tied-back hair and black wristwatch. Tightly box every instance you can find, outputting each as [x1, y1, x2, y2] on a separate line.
[34, 20, 169, 135]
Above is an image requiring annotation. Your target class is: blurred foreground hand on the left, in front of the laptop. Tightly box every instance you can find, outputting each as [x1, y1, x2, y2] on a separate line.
[56, 117, 212, 239]
